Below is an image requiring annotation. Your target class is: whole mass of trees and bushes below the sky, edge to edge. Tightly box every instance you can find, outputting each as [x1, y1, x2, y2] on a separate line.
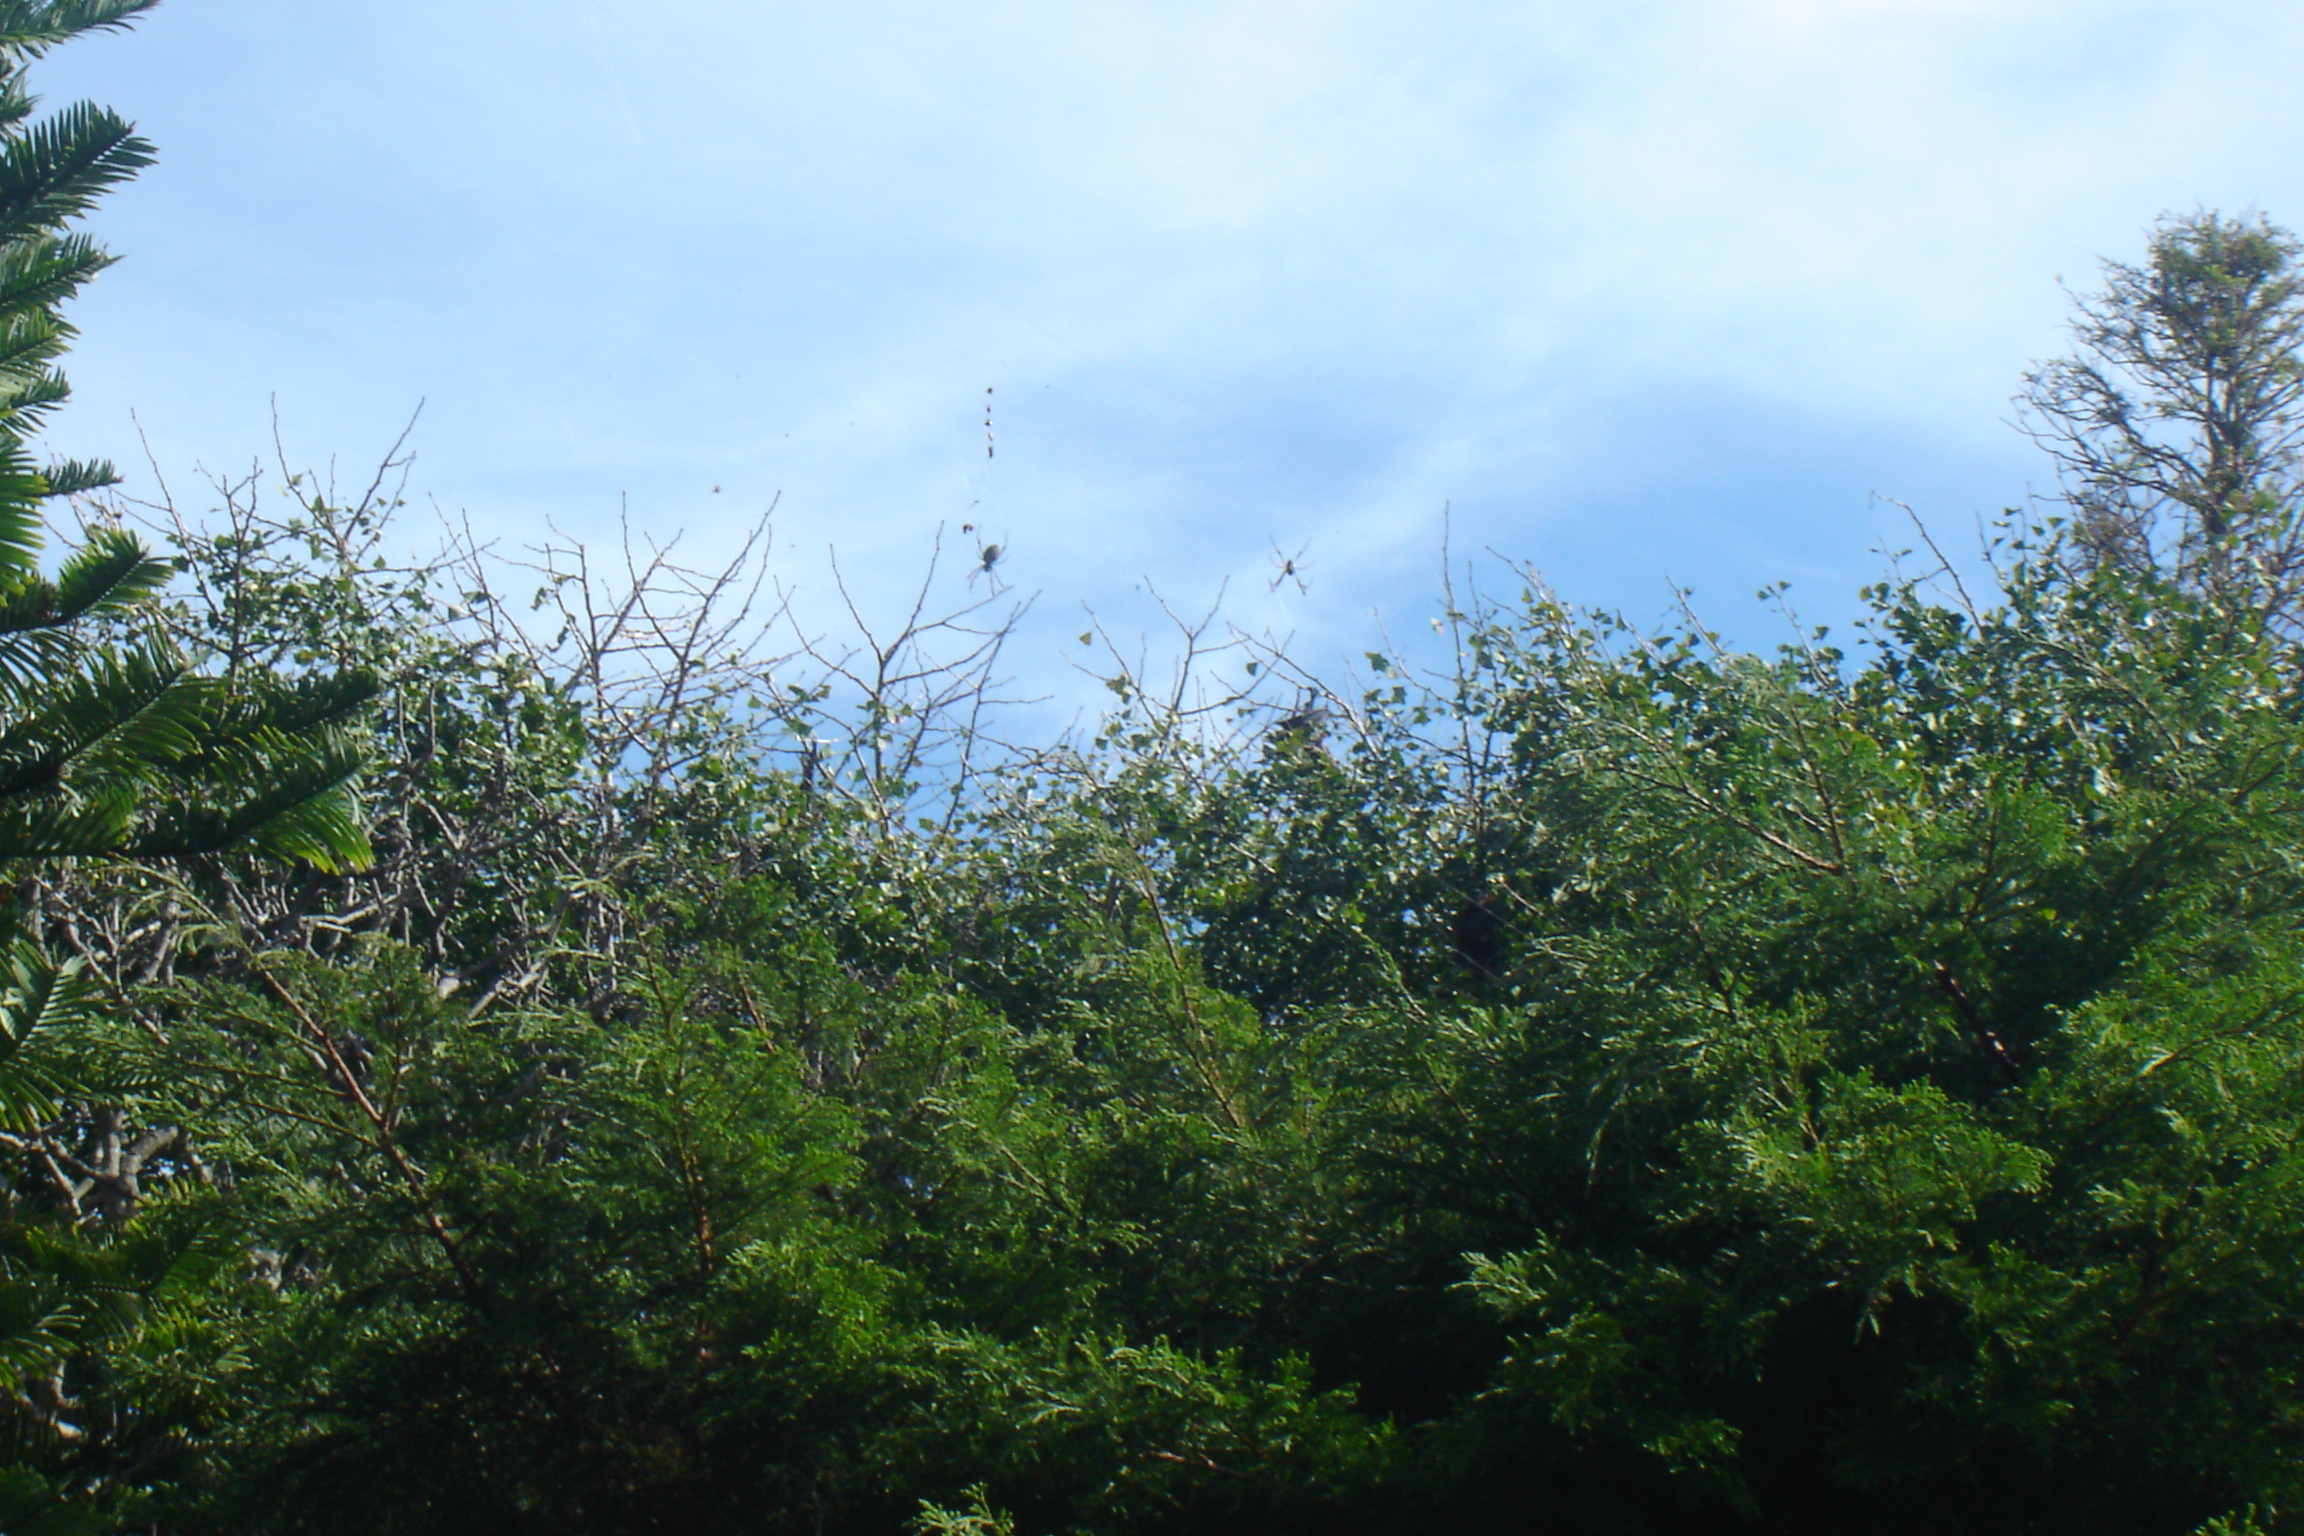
[0, 0, 2304, 1536]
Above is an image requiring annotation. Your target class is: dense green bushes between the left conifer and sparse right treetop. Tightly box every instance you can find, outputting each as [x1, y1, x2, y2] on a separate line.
[58, 474, 2304, 1534]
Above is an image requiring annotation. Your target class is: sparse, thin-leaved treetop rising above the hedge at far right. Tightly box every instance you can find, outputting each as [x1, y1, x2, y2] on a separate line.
[2018, 212, 2304, 629]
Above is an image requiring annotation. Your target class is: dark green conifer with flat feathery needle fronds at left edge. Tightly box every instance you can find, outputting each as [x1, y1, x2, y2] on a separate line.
[0, 0, 373, 1105]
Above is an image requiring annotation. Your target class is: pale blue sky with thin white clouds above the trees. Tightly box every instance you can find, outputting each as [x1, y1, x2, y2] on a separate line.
[39, 0, 2304, 704]
